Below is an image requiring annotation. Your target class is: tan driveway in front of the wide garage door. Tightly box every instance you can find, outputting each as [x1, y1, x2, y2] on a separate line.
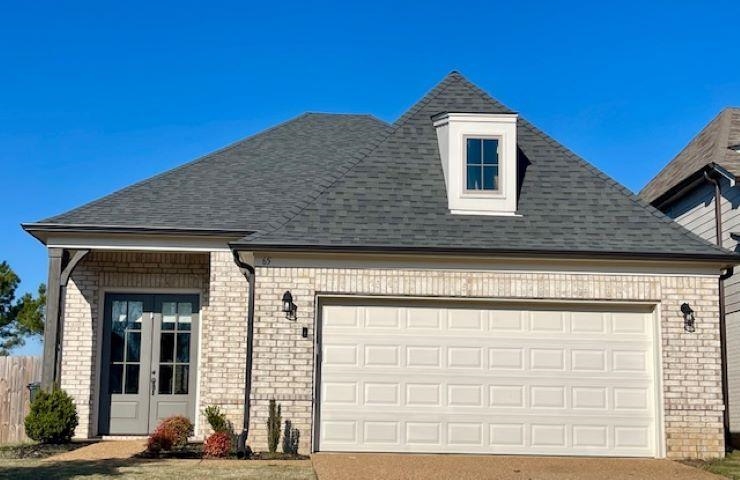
[311, 453, 726, 480]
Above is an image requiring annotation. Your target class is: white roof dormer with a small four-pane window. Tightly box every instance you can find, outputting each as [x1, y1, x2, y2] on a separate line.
[432, 112, 517, 215]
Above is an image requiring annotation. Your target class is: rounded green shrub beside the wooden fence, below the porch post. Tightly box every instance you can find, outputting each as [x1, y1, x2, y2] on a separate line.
[25, 388, 78, 443]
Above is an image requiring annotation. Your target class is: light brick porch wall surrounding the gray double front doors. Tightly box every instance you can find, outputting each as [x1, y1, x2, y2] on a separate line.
[61, 252, 247, 438]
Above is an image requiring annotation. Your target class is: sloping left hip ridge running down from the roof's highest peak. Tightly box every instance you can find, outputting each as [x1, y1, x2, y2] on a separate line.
[245, 70, 462, 240]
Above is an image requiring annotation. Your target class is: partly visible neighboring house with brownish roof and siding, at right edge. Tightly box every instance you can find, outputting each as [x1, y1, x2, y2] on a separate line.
[640, 108, 740, 446]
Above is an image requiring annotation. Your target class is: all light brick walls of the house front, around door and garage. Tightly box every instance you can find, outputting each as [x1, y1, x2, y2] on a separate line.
[62, 252, 723, 458]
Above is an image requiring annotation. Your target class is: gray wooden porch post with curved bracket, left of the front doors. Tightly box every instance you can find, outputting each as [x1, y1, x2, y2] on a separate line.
[41, 247, 90, 389]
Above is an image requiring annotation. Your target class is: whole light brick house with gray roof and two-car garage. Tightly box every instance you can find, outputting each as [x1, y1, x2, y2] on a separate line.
[24, 72, 738, 458]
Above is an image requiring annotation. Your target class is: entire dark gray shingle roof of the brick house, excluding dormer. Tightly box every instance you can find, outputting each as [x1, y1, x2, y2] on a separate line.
[29, 72, 730, 259]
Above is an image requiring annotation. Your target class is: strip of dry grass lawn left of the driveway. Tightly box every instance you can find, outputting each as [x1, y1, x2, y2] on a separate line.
[0, 459, 316, 480]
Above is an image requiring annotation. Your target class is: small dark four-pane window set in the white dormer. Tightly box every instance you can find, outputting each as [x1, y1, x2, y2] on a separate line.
[465, 137, 499, 192]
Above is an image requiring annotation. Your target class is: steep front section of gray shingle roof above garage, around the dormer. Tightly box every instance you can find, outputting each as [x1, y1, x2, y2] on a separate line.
[236, 72, 728, 257]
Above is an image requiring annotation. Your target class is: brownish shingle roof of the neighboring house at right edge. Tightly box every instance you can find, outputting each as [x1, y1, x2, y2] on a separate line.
[640, 108, 740, 203]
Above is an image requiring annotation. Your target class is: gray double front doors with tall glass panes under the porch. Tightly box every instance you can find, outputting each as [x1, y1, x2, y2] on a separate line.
[99, 294, 199, 435]
